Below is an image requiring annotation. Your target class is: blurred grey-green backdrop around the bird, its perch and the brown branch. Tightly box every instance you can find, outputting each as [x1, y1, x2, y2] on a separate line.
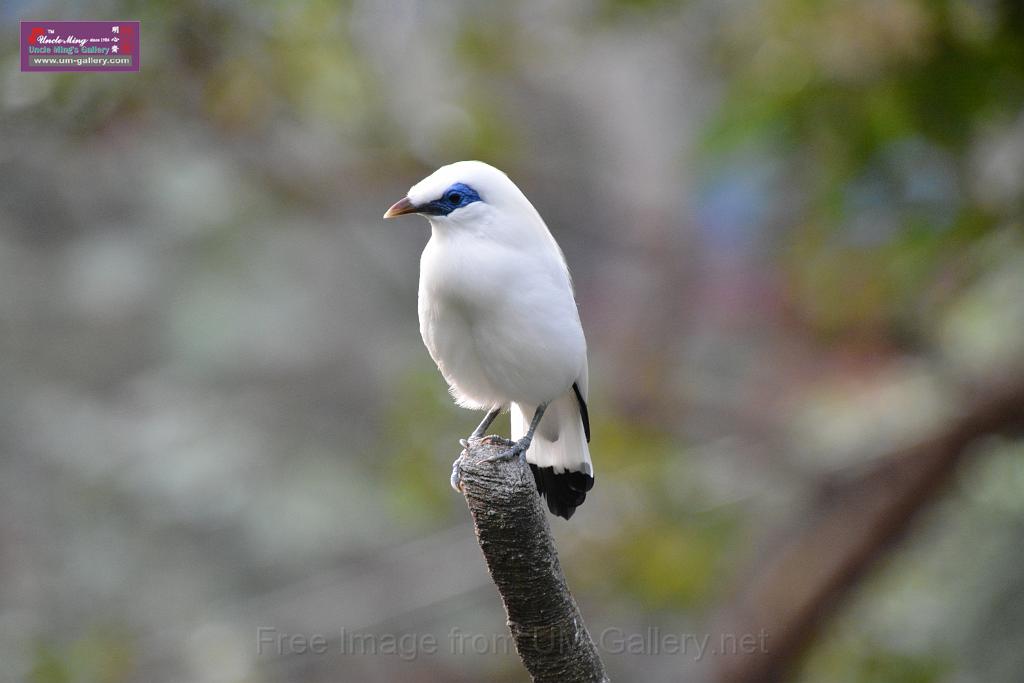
[0, 0, 1024, 683]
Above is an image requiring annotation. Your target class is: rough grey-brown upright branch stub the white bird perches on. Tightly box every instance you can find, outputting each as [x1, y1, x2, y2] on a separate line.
[462, 441, 609, 683]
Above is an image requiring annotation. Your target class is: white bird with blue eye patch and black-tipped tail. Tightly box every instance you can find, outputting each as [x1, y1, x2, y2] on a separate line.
[384, 161, 594, 519]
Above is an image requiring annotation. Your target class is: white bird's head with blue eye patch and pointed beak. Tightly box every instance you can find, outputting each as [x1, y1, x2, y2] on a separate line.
[384, 161, 528, 223]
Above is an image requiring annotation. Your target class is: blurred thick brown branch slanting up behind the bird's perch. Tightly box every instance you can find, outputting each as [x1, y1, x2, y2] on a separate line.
[717, 382, 1024, 683]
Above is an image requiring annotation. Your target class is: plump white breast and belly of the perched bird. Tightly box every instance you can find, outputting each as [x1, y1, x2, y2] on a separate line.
[419, 229, 587, 409]
